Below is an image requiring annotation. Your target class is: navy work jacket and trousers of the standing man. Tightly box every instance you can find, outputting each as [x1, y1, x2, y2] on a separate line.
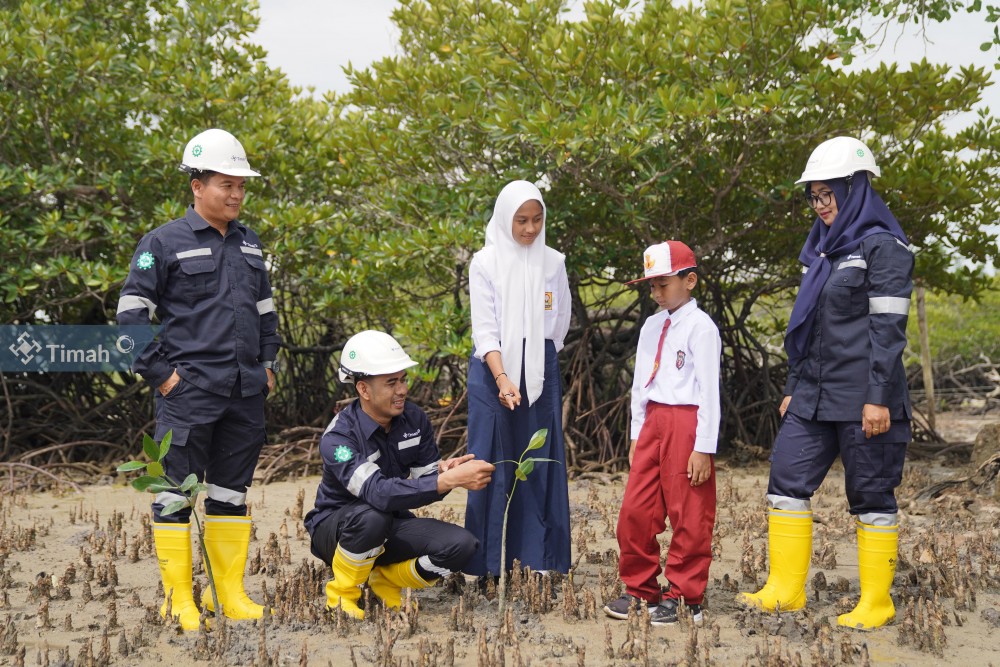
[118, 206, 281, 523]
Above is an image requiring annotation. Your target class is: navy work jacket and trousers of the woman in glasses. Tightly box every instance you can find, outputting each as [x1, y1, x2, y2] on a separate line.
[768, 233, 913, 525]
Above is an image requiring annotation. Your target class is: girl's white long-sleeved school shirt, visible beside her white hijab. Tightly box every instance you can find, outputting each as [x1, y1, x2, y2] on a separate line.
[469, 256, 572, 361]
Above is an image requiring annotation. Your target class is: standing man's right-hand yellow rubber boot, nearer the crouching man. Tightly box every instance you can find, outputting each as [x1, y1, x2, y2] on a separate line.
[201, 515, 264, 621]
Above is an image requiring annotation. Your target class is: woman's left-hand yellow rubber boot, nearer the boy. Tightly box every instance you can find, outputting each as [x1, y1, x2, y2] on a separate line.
[736, 509, 812, 611]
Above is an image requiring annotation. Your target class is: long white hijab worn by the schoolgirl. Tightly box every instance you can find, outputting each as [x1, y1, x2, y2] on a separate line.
[476, 181, 562, 405]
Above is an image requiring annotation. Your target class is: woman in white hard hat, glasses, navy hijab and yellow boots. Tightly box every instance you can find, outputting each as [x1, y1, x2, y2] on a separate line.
[740, 137, 913, 630]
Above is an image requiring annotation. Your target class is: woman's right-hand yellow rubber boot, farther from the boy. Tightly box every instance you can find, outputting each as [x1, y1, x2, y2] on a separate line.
[837, 521, 899, 630]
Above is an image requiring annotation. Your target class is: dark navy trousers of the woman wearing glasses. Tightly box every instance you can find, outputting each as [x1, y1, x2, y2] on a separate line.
[767, 412, 911, 514]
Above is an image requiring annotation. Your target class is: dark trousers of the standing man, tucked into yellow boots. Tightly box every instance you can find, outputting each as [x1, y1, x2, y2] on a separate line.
[153, 378, 265, 523]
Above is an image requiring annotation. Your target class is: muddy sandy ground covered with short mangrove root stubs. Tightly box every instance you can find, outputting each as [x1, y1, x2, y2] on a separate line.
[0, 418, 1000, 665]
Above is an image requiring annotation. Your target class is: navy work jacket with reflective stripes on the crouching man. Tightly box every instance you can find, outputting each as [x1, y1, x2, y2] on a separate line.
[305, 399, 443, 535]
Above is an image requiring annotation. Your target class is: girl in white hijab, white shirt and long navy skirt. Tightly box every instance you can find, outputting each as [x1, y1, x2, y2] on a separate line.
[464, 181, 571, 581]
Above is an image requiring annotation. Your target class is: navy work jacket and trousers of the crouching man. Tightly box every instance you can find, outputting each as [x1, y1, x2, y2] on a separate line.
[305, 399, 479, 576]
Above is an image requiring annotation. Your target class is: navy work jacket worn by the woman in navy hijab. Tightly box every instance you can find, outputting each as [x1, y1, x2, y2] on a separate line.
[785, 234, 913, 422]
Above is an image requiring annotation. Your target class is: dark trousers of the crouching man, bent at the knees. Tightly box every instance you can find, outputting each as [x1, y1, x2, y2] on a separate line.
[312, 500, 479, 572]
